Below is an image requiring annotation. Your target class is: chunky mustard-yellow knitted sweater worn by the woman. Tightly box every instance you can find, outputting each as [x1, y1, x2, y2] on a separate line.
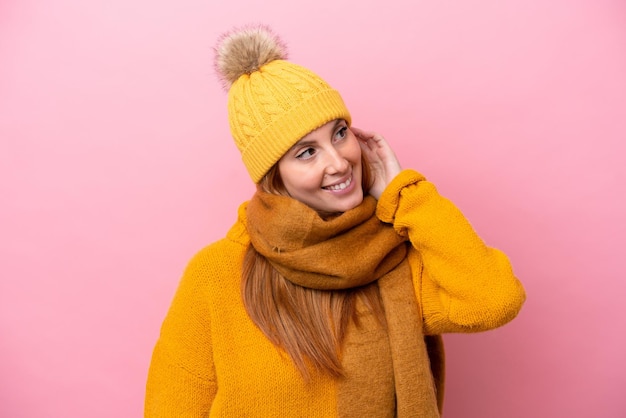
[145, 170, 525, 417]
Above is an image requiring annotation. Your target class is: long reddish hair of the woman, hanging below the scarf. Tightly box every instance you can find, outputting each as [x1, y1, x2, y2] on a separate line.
[241, 156, 386, 379]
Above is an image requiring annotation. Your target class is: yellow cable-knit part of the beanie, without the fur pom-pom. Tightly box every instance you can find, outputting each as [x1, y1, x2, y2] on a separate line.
[228, 60, 351, 183]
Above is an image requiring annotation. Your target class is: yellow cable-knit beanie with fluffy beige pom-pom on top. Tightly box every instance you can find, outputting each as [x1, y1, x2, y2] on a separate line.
[215, 26, 351, 183]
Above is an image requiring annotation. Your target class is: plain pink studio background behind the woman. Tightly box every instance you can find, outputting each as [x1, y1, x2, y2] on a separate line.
[0, 0, 626, 418]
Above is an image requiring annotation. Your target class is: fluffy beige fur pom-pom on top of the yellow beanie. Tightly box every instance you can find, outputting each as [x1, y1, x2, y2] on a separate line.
[215, 25, 288, 89]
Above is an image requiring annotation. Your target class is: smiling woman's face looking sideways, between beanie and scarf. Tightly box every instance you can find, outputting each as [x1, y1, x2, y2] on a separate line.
[278, 120, 363, 212]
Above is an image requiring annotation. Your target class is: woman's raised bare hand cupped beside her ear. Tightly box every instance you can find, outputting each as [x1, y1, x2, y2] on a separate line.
[350, 127, 402, 199]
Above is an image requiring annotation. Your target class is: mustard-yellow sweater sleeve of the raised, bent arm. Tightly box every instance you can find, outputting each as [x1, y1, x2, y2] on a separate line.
[376, 170, 526, 335]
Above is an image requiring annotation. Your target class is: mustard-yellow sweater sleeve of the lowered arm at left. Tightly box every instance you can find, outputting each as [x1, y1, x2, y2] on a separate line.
[144, 250, 217, 417]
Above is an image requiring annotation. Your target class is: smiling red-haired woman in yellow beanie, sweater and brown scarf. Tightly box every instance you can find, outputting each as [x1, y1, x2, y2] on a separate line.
[145, 27, 525, 417]
